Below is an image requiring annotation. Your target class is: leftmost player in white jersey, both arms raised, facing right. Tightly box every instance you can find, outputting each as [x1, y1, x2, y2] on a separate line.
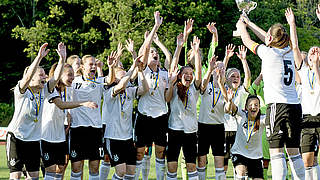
[6, 43, 65, 179]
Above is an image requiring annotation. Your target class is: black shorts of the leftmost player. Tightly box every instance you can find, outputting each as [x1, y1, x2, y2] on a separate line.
[6, 132, 41, 173]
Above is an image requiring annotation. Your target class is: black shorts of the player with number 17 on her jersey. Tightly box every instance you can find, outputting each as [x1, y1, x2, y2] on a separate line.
[70, 127, 104, 162]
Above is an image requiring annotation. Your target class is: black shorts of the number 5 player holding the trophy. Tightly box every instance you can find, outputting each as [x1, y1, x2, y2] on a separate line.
[266, 103, 302, 148]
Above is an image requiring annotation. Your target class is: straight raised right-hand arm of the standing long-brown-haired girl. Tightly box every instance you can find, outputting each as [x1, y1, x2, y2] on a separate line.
[191, 36, 202, 88]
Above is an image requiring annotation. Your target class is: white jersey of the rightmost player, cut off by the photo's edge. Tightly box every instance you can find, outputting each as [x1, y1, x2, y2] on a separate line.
[298, 63, 320, 116]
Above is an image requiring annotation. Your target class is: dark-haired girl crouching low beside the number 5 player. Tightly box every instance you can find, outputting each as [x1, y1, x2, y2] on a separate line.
[222, 90, 265, 180]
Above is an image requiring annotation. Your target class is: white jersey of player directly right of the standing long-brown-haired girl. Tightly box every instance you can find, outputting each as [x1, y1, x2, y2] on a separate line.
[199, 82, 225, 124]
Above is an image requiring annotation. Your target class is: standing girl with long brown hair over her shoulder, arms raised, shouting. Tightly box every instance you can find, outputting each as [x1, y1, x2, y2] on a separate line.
[166, 37, 201, 180]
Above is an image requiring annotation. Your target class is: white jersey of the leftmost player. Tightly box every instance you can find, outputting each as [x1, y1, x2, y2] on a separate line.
[8, 81, 56, 141]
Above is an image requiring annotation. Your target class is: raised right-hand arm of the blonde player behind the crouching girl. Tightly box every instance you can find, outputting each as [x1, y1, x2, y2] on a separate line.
[236, 45, 251, 91]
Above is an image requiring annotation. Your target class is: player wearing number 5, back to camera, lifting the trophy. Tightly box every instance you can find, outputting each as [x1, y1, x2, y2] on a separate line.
[237, 10, 305, 179]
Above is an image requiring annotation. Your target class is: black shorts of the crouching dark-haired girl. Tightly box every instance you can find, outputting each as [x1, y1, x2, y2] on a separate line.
[231, 154, 263, 179]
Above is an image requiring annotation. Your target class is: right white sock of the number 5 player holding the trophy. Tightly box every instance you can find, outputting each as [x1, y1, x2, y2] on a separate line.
[289, 154, 305, 180]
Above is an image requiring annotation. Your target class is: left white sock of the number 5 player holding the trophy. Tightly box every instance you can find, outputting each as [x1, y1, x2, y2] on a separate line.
[271, 153, 287, 180]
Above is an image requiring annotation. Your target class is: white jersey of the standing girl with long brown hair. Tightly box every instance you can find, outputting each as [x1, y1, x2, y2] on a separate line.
[169, 83, 199, 133]
